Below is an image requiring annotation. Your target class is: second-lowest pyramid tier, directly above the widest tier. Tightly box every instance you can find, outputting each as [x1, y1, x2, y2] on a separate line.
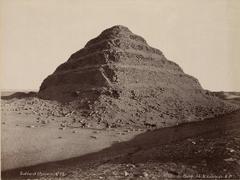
[55, 49, 183, 73]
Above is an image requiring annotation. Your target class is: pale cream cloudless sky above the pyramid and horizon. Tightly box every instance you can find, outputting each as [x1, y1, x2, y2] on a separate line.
[0, 0, 240, 91]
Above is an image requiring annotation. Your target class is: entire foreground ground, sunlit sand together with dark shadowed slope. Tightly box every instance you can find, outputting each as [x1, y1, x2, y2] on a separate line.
[1, 92, 240, 179]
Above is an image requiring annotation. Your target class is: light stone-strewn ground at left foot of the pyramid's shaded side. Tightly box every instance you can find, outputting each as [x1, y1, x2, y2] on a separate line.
[1, 97, 86, 127]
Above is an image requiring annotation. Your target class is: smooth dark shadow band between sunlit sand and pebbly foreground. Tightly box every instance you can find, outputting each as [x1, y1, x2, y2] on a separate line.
[2, 111, 240, 179]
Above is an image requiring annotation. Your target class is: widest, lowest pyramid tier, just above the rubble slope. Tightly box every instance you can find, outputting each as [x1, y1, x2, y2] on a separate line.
[40, 63, 202, 100]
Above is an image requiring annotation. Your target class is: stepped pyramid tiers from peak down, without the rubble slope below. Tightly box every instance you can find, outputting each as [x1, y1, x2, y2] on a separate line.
[40, 26, 201, 101]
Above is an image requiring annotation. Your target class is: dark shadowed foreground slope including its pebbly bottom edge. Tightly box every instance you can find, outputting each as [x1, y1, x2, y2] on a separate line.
[2, 92, 240, 179]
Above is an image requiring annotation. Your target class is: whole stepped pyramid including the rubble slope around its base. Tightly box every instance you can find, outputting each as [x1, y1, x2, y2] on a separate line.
[38, 26, 239, 128]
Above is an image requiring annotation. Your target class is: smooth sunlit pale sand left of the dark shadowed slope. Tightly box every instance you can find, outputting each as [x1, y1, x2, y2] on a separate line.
[2, 107, 139, 170]
